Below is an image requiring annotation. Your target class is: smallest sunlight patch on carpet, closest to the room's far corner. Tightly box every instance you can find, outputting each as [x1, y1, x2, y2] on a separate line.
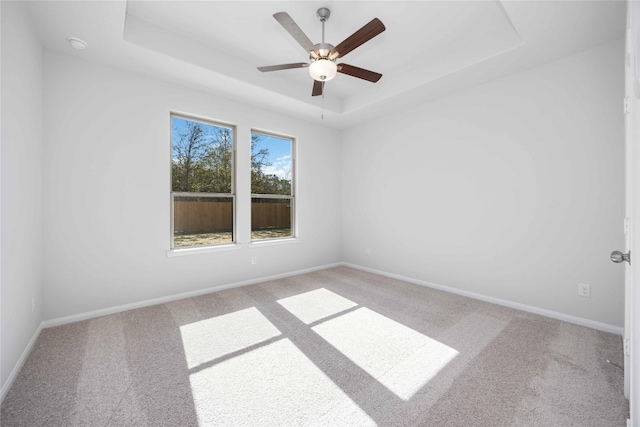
[278, 288, 358, 325]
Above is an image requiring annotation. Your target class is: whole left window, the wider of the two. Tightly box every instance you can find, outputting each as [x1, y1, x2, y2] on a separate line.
[171, 114, 235, 249]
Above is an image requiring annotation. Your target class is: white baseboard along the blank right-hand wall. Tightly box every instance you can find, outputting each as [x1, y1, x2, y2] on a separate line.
[341, 262, 624, 335]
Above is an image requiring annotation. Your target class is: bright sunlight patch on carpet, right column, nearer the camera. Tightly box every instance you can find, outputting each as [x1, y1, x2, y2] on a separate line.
[312, 307, 459, 401]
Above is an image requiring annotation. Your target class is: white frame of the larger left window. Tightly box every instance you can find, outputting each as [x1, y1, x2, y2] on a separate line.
[168, 111, 238, 254]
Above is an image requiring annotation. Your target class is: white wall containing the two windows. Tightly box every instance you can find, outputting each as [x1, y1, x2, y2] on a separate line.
[44, 52, 341, 319]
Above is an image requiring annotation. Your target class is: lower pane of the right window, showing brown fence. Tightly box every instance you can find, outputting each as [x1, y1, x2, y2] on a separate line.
[251, 198, 293, 240]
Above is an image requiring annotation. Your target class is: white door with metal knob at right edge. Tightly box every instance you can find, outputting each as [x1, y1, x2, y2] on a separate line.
[623, 1, 640, 427]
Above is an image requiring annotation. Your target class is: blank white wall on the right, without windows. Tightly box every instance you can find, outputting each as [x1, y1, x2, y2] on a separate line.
[342, 41, 624, 326]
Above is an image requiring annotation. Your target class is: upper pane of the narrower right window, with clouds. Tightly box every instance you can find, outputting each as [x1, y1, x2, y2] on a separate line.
[251, 132, 293, 196]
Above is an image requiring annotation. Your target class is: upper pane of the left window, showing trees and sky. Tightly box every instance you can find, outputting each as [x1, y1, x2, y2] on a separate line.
[171, 116, 233, 194]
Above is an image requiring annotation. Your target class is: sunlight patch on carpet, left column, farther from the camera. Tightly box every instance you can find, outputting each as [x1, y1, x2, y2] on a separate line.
[180, 307, 281, 369]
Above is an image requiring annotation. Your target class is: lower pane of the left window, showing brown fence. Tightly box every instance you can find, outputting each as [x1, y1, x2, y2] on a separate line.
[173, 197, 233, 248]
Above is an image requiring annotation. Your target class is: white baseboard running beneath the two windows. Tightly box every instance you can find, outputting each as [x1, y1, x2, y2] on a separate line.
[42, 262, 342, 328]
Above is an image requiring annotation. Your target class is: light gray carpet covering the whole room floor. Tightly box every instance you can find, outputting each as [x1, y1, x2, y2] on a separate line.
[1, 267, 628, 427]
